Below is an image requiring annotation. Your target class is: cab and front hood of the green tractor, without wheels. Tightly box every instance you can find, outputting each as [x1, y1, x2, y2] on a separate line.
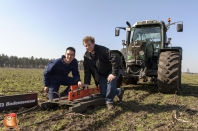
[122, 20, 164, 78]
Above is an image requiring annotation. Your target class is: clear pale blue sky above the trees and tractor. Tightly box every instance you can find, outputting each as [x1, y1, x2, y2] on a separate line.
[0, 0, 198, 72]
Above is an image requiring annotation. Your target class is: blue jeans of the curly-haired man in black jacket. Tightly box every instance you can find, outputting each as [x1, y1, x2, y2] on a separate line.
[99, 71, 120, 104]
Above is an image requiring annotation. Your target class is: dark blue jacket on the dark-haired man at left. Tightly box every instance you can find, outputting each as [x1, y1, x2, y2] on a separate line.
[43, 55, 80, 86]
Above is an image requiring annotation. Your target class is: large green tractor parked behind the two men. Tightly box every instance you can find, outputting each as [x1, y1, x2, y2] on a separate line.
[114, 18, 183, 94]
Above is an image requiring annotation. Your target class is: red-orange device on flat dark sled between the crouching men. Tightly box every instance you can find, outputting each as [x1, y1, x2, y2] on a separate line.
[39, 85, 105, 113]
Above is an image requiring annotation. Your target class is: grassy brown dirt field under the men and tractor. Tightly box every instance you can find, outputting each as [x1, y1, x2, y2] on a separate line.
[0, 68, 198, 131]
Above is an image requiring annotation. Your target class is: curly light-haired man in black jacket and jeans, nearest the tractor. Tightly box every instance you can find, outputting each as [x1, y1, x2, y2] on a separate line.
[83, 36, 124, 110]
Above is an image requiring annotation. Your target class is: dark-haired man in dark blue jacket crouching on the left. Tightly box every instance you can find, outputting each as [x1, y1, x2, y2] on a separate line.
[43, 47, 83, 100]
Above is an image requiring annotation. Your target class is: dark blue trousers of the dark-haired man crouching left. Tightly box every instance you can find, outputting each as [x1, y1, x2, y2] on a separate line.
[48, 77, 75, 100]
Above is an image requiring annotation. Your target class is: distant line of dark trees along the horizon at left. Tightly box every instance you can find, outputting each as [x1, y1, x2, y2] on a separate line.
[0, 54, 83, 70]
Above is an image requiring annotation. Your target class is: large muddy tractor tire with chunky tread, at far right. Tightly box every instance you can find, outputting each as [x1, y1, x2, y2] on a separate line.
[157, 51, 181, 94]
